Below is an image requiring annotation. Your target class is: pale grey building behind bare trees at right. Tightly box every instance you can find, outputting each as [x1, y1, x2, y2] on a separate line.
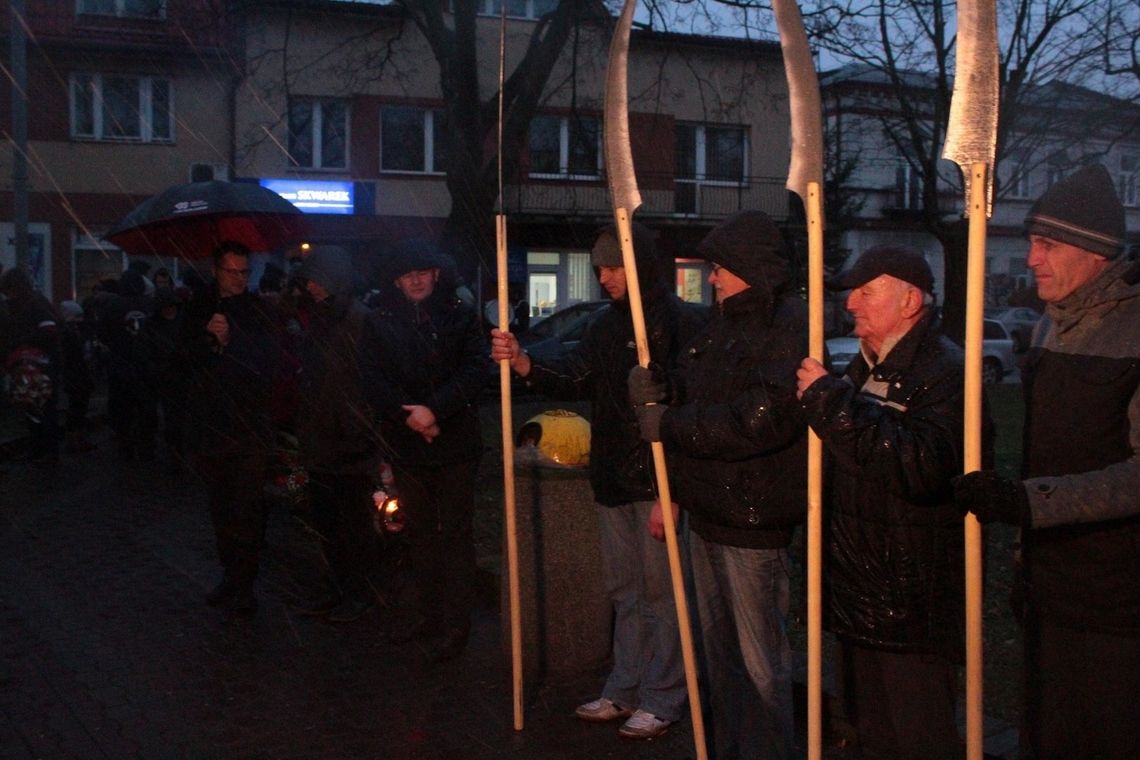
[821, 64, 1140, 305]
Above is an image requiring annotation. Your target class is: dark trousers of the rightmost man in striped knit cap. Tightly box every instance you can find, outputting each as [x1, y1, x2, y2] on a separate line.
[1021, 619, 1140, 760]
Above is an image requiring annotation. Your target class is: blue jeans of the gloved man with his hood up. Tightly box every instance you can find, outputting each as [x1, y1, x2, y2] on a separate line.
[689, 532, 796, 760]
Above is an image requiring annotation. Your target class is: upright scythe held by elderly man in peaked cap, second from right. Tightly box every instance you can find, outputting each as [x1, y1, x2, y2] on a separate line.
[772, 0, 823, 760]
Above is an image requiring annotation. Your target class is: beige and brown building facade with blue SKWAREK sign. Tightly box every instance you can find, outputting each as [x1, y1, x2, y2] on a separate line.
[0, 0, 789, 313]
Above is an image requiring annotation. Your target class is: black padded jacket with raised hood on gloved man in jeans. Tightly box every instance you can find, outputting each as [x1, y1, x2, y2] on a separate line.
[661, 287, 807, 549]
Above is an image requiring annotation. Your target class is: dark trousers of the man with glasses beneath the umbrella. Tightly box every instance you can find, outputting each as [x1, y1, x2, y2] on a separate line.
[195, 450, 268, 588]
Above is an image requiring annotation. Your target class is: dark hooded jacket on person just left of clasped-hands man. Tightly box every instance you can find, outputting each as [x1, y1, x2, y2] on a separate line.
[296, 246, 378, 474]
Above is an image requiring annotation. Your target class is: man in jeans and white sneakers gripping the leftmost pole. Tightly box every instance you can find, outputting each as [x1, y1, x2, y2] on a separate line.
[491, 224, 707, 738]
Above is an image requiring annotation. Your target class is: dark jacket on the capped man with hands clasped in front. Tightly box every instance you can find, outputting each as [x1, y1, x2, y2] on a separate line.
[360, 247, 491, 466]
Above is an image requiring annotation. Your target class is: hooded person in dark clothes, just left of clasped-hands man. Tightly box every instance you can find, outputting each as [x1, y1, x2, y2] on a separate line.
[289, 245, 380, 622]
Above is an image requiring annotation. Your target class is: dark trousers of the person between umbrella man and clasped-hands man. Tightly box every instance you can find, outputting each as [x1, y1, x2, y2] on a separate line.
[309, 472, 378, 600]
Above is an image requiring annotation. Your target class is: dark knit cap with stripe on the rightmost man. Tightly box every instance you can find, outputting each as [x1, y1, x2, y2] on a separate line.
[1025, 164, 1126, 259]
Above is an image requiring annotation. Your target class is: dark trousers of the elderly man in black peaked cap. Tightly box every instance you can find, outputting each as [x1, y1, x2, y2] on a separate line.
[841, 641, 964, 760]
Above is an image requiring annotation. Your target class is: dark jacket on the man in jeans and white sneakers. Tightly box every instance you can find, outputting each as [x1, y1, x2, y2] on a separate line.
[526, 228, 708, 507]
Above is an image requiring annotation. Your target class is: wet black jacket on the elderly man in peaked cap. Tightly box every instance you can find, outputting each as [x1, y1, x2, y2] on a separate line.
[803, 316, 964, 656]
